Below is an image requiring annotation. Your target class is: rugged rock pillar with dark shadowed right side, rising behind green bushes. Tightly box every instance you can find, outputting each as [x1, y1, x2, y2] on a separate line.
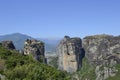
[24, 39, 44, 60]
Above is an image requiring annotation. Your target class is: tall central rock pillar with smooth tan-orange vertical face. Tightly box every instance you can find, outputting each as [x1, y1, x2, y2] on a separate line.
[58, 36, 85, 73]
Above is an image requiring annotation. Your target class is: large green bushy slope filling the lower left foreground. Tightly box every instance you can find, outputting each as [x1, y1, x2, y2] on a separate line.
[0, 46, 70, 80]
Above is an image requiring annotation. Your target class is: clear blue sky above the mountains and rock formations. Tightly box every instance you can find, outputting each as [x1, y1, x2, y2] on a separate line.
[0, 0, 120, 37]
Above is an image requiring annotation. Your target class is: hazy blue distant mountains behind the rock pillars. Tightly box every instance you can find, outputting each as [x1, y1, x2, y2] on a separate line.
[0, 33, 61, 52]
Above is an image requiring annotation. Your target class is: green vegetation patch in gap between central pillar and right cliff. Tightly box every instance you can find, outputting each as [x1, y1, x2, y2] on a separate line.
[71, 57, 96, 80]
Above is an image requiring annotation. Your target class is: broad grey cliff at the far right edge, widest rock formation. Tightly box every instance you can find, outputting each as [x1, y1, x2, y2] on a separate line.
[83, 35, 120, 80]
